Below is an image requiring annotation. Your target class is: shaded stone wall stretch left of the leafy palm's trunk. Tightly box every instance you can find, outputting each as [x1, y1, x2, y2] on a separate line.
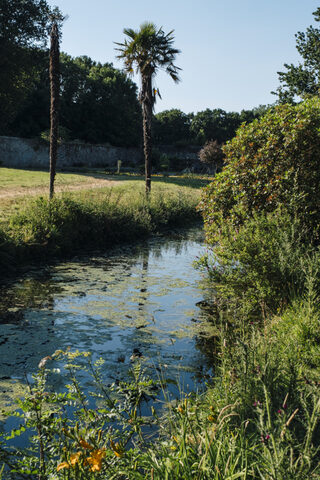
[0, 137, 143, 168]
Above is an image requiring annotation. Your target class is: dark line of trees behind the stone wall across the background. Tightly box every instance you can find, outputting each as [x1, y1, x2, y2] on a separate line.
[0, 0, 265, 152]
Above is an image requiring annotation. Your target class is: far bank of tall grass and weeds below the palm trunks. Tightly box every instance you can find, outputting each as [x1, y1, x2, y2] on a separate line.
[0, 172, 207, 273]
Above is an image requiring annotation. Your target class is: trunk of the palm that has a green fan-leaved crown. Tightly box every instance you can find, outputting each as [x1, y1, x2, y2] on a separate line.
[140, 76, 154, 195]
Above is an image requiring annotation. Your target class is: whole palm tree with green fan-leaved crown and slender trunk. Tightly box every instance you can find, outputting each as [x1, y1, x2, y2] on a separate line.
[116, 22, 180, 194]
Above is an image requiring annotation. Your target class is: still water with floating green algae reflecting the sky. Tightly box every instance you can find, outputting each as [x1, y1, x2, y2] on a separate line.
[0, 229, 218, 426]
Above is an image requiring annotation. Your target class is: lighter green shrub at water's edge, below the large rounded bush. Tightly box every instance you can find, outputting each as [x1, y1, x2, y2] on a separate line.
[196, 209, 320, 321]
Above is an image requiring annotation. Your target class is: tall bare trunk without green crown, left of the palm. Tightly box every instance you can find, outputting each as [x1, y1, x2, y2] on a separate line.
[49, 21, 60, 199]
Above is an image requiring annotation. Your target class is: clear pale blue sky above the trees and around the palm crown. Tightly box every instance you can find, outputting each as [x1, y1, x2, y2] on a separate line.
[48, 0, 320, 113]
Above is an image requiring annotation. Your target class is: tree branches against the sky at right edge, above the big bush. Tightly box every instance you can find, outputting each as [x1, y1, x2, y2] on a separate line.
[272, 7, 320, 103]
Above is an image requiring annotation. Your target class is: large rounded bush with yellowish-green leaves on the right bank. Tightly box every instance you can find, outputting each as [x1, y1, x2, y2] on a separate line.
[200, 98, 320, 244]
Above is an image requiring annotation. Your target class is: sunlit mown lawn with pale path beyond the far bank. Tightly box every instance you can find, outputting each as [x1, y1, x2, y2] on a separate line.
[0, 167, 209, 221]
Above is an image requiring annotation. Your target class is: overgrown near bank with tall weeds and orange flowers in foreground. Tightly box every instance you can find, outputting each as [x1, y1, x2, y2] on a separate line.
[0, 214, 320, 480]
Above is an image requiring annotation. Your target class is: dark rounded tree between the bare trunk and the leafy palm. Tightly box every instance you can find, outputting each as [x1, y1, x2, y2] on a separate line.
[61, 55, 141, 146]
